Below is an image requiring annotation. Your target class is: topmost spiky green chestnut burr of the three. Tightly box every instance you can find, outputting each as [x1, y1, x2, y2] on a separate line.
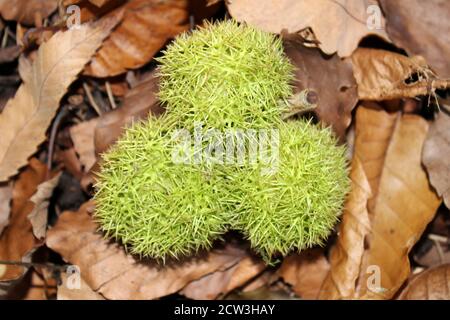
[158, 20, 293, 130]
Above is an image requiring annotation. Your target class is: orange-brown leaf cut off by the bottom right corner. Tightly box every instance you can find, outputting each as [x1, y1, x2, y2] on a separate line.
[399, 264, 450, 300]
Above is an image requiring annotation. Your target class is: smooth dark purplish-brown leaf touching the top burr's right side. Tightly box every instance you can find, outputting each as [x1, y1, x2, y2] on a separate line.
[285, 36, 358, 140]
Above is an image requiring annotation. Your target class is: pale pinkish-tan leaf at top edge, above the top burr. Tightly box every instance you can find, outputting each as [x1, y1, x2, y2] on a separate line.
[227, 0, 389, 57]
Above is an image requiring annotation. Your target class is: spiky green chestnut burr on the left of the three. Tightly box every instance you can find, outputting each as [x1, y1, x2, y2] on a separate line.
[95, 117, 228, 260]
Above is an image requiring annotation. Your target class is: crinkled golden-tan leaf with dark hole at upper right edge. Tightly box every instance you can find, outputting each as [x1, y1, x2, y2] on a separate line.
[352, 48, 450, 101]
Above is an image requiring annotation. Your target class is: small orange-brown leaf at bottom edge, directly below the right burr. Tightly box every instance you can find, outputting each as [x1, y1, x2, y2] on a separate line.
[277, 249, 330, 299]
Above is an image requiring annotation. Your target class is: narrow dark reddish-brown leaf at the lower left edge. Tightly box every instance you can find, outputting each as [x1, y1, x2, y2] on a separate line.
[0, 158, 47, 283]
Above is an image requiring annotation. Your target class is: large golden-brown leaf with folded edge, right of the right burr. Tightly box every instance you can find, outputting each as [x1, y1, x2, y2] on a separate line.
[320, 106, 441, 299]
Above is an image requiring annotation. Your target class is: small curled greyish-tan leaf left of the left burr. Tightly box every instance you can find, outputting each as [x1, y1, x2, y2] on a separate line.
[28, 173, 61, 239]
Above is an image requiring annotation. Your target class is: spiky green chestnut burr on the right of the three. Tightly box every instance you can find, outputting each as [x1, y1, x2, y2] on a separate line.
[224, 120, 349, 262]
